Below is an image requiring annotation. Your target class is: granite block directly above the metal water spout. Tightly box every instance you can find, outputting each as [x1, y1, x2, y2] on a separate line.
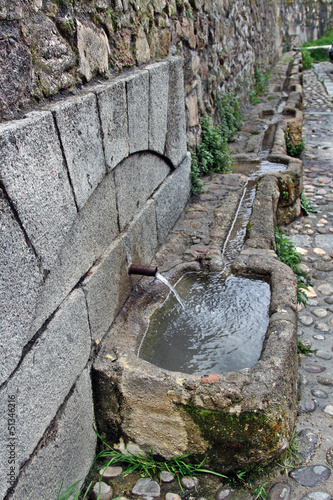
[125, 200, 157, 265]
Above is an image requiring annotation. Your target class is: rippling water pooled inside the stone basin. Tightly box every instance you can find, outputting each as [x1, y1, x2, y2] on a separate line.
[139, 273, 270, 374]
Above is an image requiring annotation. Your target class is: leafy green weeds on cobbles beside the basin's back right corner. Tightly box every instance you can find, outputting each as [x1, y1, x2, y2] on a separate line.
[274, 227, 311, 306]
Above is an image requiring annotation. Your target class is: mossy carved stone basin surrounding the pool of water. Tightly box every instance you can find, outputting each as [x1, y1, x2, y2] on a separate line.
[93, 170, 298, 472]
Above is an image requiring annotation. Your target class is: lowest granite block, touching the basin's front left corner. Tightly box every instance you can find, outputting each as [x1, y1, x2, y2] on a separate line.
[12, 369, 96, 500]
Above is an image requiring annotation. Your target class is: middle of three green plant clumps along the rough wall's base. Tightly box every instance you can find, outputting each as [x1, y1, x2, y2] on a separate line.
[215, 92, 243, 142]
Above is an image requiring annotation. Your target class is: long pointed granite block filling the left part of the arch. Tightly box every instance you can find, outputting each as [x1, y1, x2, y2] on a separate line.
[33, 173, 119, 332]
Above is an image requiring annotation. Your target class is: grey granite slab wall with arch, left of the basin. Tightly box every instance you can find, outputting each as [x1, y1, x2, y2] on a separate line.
[0, 57, 190, 500]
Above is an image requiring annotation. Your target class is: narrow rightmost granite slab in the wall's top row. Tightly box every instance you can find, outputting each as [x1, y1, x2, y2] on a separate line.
[165, 57, 187, 168]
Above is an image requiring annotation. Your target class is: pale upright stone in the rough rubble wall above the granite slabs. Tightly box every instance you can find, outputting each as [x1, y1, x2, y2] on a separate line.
[76, 19, 110, 81]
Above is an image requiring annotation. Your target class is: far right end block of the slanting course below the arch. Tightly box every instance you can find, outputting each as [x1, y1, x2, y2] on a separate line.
[154, 153, 191, 244]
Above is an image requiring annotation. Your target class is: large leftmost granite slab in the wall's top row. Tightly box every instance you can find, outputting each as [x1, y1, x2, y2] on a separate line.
[0, 112, 77, 269]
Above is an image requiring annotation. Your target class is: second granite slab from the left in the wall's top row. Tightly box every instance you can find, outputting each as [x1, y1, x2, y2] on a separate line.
[52, 94, 105, 209]
